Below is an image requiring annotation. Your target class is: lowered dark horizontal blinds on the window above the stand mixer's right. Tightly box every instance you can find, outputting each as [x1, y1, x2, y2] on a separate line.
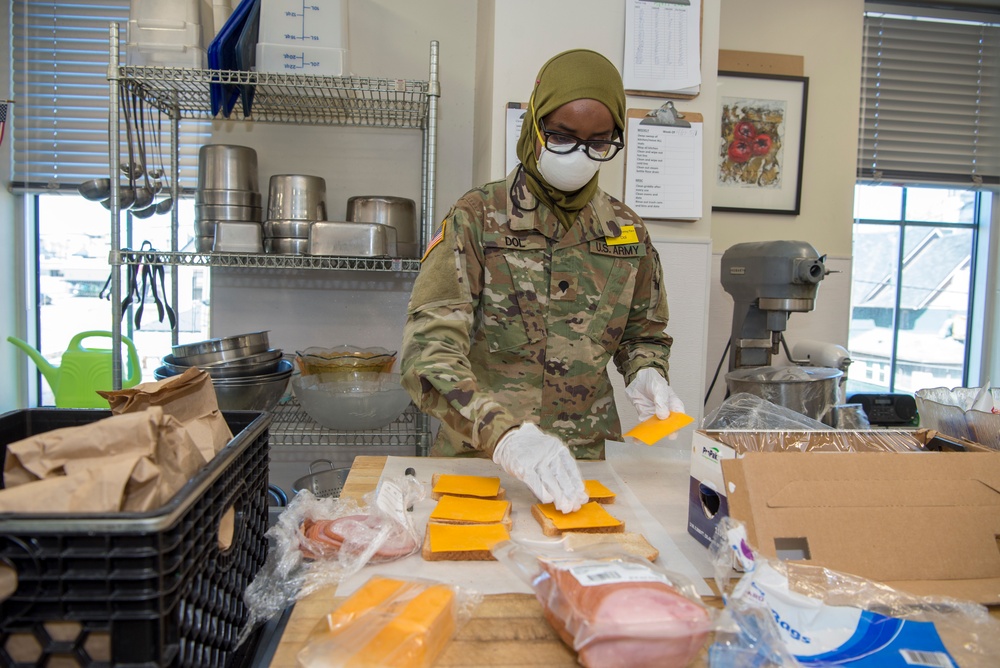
[858, 6, 1000, 185]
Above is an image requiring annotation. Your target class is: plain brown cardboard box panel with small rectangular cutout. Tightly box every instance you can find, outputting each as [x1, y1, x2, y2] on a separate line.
[722, 452, 1000, 605]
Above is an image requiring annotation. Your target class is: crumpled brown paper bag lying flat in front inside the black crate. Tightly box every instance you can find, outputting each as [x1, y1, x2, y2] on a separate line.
[0, 407, 206, 513]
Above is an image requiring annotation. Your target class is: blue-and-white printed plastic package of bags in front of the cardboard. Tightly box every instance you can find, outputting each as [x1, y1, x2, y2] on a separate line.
[709, 518, 1000, 668]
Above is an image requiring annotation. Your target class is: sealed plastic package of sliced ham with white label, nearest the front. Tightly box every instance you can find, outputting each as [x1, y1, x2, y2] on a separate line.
[492, 541, 713, 668]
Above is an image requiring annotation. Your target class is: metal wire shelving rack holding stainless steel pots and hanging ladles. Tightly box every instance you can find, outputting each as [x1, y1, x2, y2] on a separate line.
[108, 23, 440, 454]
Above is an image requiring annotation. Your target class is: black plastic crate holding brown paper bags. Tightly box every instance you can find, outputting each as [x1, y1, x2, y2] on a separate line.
[0, 408, 271, 667]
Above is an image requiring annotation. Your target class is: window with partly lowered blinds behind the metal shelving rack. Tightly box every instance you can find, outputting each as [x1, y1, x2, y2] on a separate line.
[9, 0, 210, 405]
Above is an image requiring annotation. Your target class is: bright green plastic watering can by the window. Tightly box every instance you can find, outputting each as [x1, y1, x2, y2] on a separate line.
[7, 331, 142, 408]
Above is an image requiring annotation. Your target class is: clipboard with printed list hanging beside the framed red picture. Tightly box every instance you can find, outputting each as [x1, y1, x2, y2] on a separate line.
[625, 100, 704, 221]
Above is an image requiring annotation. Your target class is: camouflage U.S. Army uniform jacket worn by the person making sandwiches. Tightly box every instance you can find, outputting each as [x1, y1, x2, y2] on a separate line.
[402, 171, 672, 459]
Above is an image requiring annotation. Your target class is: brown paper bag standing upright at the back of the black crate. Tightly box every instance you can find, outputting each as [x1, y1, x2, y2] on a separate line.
[98, 367, 233, 461]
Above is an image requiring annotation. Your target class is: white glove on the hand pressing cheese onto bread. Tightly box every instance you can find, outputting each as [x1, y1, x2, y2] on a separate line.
[493, 422, 590, 513]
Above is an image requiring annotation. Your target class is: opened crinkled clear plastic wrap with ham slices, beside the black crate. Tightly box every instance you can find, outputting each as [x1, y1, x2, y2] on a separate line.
[244, 475, 425, 635]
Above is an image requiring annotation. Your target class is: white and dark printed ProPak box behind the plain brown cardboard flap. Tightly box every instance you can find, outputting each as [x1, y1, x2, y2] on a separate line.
[688, 429, 925, 547]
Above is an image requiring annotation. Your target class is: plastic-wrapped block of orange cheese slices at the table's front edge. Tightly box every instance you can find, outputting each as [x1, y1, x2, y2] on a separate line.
[298, 576, 482, 668]
